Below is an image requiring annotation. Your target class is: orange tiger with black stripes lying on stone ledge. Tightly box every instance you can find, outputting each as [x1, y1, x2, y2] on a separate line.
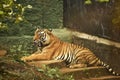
[21, 29, 119, 75]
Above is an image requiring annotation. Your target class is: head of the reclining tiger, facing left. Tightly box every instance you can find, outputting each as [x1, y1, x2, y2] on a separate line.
[33, 28, 52, 47]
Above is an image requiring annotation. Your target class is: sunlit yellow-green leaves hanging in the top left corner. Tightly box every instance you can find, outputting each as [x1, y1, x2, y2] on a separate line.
[0, 0, 32, 35]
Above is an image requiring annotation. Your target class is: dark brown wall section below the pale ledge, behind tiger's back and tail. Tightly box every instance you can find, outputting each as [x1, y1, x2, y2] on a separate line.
[72, 33, 120, 73]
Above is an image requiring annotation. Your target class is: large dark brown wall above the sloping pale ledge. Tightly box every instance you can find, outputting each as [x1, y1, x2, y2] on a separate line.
[63, 0, 120, 42]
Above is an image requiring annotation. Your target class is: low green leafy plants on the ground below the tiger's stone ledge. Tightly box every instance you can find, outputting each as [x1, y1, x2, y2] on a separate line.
[37, 65, 74, 80]
